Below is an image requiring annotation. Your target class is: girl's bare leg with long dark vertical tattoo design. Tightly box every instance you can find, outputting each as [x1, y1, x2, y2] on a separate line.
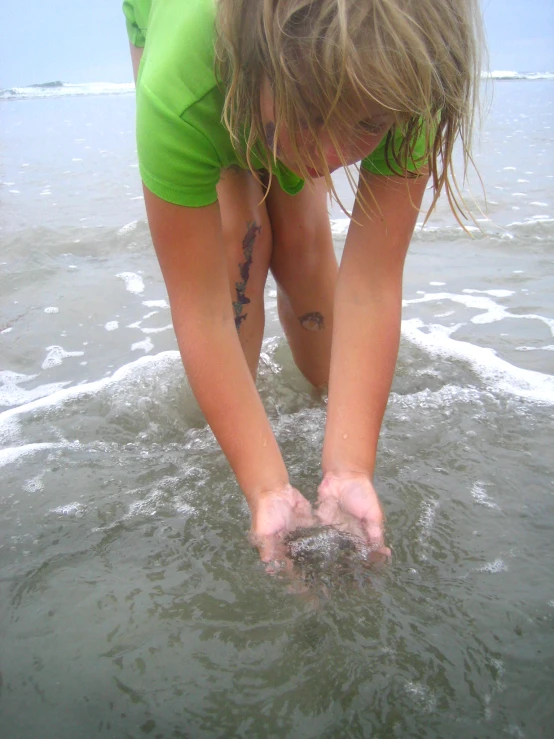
[217, 169, 271, 378]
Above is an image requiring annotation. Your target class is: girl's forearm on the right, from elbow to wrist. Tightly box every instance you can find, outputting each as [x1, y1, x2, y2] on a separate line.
[323, 282, 401, 478]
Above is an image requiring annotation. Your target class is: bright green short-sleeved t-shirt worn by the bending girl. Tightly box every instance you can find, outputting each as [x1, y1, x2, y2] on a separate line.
[123, 0, 424, 207]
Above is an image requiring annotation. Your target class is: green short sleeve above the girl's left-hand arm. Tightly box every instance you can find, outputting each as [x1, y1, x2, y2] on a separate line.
[137, 83, 221, 208]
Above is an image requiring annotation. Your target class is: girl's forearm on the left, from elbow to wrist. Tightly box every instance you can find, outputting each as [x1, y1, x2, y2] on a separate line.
[174, 310, 288, 508]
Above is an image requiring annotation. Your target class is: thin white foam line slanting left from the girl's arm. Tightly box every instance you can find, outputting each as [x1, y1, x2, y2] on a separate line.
[0, 351, 179, 434]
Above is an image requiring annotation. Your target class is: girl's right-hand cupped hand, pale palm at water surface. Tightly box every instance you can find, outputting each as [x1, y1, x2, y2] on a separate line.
[317, 474, 391, 562]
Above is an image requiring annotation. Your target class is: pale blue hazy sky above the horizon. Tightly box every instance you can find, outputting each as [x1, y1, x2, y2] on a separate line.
[0, 0, 554, 89]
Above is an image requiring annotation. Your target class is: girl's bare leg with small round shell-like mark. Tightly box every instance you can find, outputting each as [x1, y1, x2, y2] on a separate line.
[267, 180, 338, 387]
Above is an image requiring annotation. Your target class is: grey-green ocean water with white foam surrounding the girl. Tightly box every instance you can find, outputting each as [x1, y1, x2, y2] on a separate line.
[0, 78, 554, 739]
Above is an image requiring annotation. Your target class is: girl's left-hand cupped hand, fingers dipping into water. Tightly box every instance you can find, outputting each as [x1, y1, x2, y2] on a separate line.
[250, 485, 316, 571]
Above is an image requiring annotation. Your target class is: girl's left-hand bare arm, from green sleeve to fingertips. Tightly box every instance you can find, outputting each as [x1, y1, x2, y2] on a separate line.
[144, 188, 312, 560]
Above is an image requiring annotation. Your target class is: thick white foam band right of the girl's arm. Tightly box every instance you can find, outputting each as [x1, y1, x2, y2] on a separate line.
[402, 318, 554, 405]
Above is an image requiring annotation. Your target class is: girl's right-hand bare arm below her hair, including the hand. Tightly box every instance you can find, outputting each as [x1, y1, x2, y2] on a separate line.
[319, 171, 427, 546]
